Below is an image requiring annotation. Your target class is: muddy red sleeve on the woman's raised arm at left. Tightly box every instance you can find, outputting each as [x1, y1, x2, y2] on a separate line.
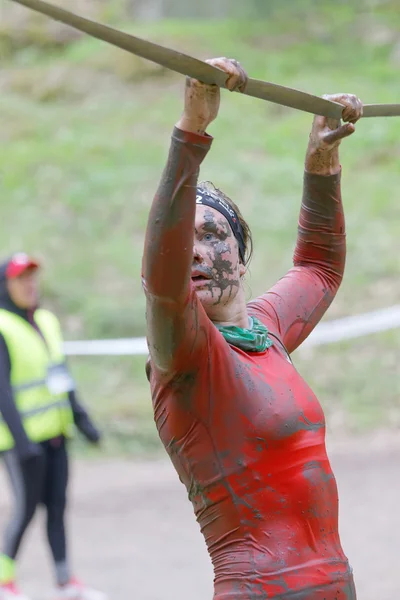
[142, 127, 212, 371]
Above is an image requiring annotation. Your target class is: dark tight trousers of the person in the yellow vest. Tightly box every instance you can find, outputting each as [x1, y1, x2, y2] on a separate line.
[2, 438, 70, 583]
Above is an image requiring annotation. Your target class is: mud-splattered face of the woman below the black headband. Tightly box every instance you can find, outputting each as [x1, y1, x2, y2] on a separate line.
[192, 205, 245, 309]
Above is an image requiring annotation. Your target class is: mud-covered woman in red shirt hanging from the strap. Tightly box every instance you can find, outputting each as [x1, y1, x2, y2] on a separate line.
[142, 58, 362, 600]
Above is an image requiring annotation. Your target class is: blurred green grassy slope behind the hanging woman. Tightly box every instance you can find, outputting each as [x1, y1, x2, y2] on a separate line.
[0, 3, 400, 451]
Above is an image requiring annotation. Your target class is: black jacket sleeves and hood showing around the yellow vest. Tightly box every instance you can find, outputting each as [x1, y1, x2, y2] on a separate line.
[0, 261, 100, 459]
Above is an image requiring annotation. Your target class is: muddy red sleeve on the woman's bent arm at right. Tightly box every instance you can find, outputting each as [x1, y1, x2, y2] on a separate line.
[249, 173, 346, 352]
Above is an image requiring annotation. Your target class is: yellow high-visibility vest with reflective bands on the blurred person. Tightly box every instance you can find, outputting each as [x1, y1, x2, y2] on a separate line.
[0, 309, 74, 452]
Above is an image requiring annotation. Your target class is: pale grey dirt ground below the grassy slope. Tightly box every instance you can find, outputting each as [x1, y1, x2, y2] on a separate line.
[0, 433, 400, 600]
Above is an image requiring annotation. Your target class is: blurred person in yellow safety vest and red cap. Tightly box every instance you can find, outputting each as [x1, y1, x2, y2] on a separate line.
[0, 253, 105, 600]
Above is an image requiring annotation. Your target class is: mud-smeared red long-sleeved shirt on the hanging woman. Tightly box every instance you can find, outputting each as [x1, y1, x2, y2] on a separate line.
[143, 125, 355, 600]
